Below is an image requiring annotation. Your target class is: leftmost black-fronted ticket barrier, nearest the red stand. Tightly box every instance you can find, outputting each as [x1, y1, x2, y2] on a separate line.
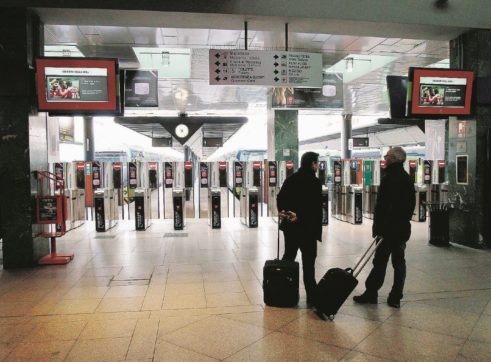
[94, 189, 118, 232]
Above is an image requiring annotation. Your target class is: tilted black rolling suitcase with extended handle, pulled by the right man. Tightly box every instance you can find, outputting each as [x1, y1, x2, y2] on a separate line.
[315, 237, 382, 320]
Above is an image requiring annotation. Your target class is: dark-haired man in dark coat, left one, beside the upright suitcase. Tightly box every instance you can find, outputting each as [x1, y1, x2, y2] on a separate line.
[277, 152, 322, 306]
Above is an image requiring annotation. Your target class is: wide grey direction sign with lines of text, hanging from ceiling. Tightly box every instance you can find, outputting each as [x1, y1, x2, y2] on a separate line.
[209, 49, 322, 88]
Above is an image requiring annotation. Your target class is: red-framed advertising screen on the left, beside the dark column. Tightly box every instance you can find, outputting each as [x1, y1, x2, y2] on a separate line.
[36, 58, 118, 113]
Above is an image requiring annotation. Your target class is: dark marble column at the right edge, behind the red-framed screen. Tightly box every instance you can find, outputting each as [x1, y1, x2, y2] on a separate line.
[447, 30, 491, 248]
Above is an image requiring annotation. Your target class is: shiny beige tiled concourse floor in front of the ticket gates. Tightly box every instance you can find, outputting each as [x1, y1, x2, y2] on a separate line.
[0, 218, 491, 361]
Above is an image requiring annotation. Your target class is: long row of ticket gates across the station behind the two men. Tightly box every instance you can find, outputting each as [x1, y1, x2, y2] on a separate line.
[51, 160, 446, 232]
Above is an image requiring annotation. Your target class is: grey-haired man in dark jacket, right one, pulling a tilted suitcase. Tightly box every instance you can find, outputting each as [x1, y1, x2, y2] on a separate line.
[353, 147, 416, 308]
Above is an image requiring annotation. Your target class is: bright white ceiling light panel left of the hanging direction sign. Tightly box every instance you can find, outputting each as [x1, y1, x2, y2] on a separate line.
[133, 47, 191, 79]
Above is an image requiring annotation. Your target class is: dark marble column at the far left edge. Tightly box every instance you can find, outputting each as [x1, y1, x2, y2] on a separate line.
[0, 8, 48, 269]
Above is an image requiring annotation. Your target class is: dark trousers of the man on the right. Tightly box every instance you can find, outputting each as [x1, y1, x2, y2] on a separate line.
[365, 239, 406, 300]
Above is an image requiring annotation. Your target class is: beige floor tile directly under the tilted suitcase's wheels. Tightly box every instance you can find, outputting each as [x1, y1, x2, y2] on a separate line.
[279, 311, 380, 349]
